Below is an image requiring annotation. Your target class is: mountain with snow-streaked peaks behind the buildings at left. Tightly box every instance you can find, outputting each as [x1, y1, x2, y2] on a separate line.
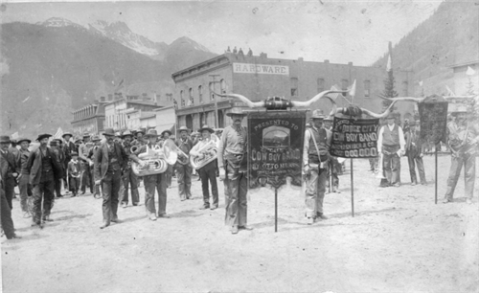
[0, 18, 215, 137]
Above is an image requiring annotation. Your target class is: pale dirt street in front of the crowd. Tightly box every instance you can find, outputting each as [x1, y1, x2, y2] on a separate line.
[1, 156, 479, 293]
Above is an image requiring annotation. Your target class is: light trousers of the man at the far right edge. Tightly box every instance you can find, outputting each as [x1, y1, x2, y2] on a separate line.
[445, 155, 476, 200]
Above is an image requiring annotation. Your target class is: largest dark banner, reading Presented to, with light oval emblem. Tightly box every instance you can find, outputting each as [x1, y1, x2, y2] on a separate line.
[248, 111, 306, 189]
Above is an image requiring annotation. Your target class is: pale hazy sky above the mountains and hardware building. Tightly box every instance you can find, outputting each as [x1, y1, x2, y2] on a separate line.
[0, 0, 442, 66]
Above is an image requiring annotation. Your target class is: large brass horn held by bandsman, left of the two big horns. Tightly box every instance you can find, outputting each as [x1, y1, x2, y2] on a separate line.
[131, 139, 178, 176]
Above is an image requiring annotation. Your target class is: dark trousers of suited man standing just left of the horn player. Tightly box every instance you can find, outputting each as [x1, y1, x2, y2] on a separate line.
[101, 171, 121, 225]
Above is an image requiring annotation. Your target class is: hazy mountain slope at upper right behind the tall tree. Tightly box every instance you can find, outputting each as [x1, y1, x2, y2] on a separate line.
[374, 1, 479, 96]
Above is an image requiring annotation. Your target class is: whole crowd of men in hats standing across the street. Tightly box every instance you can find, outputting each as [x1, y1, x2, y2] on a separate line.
[0, 109, 479, 239]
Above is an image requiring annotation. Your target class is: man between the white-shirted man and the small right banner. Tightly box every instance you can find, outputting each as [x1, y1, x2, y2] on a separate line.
[404, 120, 426, 186]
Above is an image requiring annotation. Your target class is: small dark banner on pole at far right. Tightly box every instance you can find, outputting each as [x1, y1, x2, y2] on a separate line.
[418, 95, 448, 144]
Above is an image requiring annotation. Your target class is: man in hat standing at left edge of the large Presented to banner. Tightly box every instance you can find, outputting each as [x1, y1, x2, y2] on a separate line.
[218, 109, 252, 234]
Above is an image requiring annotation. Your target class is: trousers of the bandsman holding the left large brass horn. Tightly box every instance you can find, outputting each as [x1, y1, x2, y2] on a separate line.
[143, 173, 168, 216]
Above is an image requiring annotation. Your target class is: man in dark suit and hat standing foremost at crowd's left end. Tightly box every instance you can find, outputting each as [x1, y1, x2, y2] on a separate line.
[27, 134, 61, 228]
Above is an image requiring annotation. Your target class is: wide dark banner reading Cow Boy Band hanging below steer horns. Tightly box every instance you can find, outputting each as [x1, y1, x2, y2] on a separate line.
[329, 117, 379, 158]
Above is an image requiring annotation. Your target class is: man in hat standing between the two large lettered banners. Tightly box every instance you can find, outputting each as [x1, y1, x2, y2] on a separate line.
[303, 109, 331, 225]
